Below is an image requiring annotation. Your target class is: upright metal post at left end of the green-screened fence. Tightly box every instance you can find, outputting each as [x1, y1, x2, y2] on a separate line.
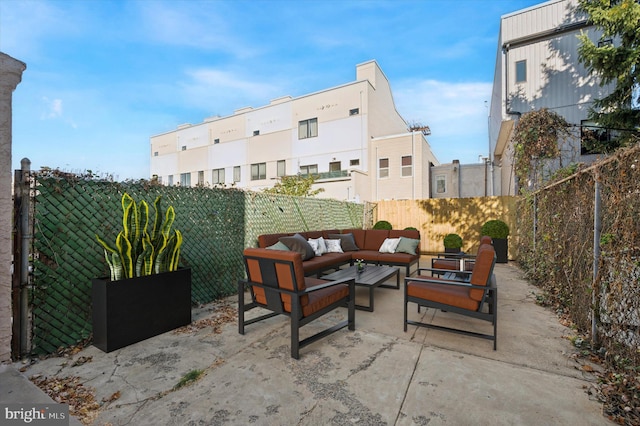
[20, 158, 31, 355]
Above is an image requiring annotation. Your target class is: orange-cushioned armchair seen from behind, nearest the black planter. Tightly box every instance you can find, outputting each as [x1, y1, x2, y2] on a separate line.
[238, 248, 355, 359]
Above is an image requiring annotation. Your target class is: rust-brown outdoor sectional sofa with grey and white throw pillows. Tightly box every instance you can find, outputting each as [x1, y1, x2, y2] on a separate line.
[258, 229, 420, 277]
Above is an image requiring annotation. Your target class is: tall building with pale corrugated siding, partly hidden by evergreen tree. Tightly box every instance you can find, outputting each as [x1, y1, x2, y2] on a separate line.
[489, 0, 615, 195]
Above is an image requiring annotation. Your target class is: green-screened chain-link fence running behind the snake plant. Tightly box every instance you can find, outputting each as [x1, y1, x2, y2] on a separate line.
[30, 174, 364, 354]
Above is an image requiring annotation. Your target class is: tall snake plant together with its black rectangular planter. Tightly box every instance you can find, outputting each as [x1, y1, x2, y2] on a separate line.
[91, 193, 191, 352]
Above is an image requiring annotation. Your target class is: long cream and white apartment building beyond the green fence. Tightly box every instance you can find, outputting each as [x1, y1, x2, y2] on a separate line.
[151, 61, 439, 201]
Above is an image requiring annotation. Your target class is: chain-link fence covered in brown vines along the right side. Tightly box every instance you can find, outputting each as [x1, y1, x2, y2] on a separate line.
[517, 141, 640, 365]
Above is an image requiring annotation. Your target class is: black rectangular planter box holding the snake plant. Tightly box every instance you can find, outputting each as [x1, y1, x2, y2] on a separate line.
[91, 268, 191, 352]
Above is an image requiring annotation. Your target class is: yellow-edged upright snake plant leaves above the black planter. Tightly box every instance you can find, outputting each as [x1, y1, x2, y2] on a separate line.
[96, 193, 182, 281]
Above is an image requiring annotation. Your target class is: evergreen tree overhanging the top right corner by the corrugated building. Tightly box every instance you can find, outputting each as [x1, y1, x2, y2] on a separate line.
[578, 0, 640, 151]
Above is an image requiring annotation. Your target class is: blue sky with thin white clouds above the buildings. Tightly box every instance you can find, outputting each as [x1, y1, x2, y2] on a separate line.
[0, 0, 541, 180]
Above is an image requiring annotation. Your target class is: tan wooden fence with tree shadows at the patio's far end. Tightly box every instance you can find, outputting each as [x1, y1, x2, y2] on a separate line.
[376, 197, 517, 253]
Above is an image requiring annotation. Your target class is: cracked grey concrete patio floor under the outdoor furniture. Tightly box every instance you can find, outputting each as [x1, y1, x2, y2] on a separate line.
[0, 257, 610, 426]
